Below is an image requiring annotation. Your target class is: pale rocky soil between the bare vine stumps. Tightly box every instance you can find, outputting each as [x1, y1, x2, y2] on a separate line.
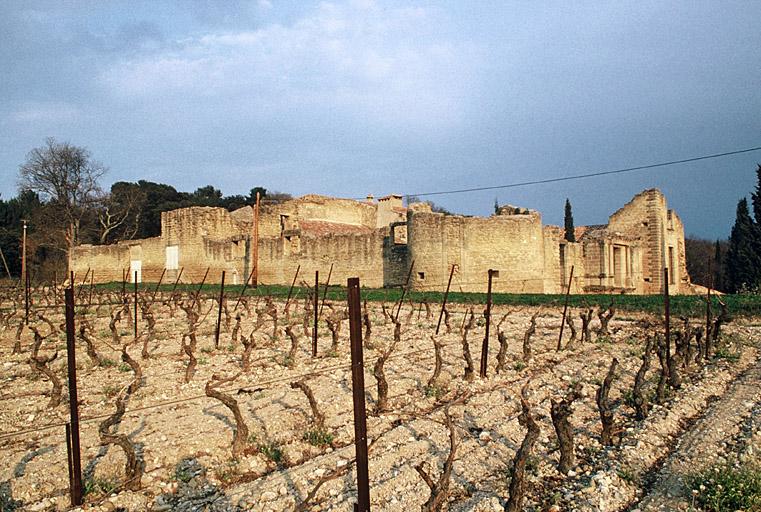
[0, 290, 761, 512]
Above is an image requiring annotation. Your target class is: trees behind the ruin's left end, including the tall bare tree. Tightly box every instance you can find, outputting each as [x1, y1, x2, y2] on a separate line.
[0, 138, 290, 276]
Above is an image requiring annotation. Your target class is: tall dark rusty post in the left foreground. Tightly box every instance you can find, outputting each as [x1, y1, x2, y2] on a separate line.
[65, 286, 82, 506]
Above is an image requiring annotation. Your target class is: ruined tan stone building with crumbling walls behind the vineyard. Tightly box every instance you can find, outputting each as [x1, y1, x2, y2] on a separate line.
[70, 189, 691, 294]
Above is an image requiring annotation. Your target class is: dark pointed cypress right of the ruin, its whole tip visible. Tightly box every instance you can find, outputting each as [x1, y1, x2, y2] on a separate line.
[725, 198, 761, 293]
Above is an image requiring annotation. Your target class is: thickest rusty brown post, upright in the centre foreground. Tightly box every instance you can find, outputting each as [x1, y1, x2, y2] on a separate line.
[347, 277, 370, 512]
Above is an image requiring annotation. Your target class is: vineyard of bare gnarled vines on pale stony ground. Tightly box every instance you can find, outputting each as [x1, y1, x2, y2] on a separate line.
[0, 286, 759, 511]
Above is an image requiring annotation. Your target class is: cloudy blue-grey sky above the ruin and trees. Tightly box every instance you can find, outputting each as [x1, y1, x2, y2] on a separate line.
[0, 0, 761, 238]
